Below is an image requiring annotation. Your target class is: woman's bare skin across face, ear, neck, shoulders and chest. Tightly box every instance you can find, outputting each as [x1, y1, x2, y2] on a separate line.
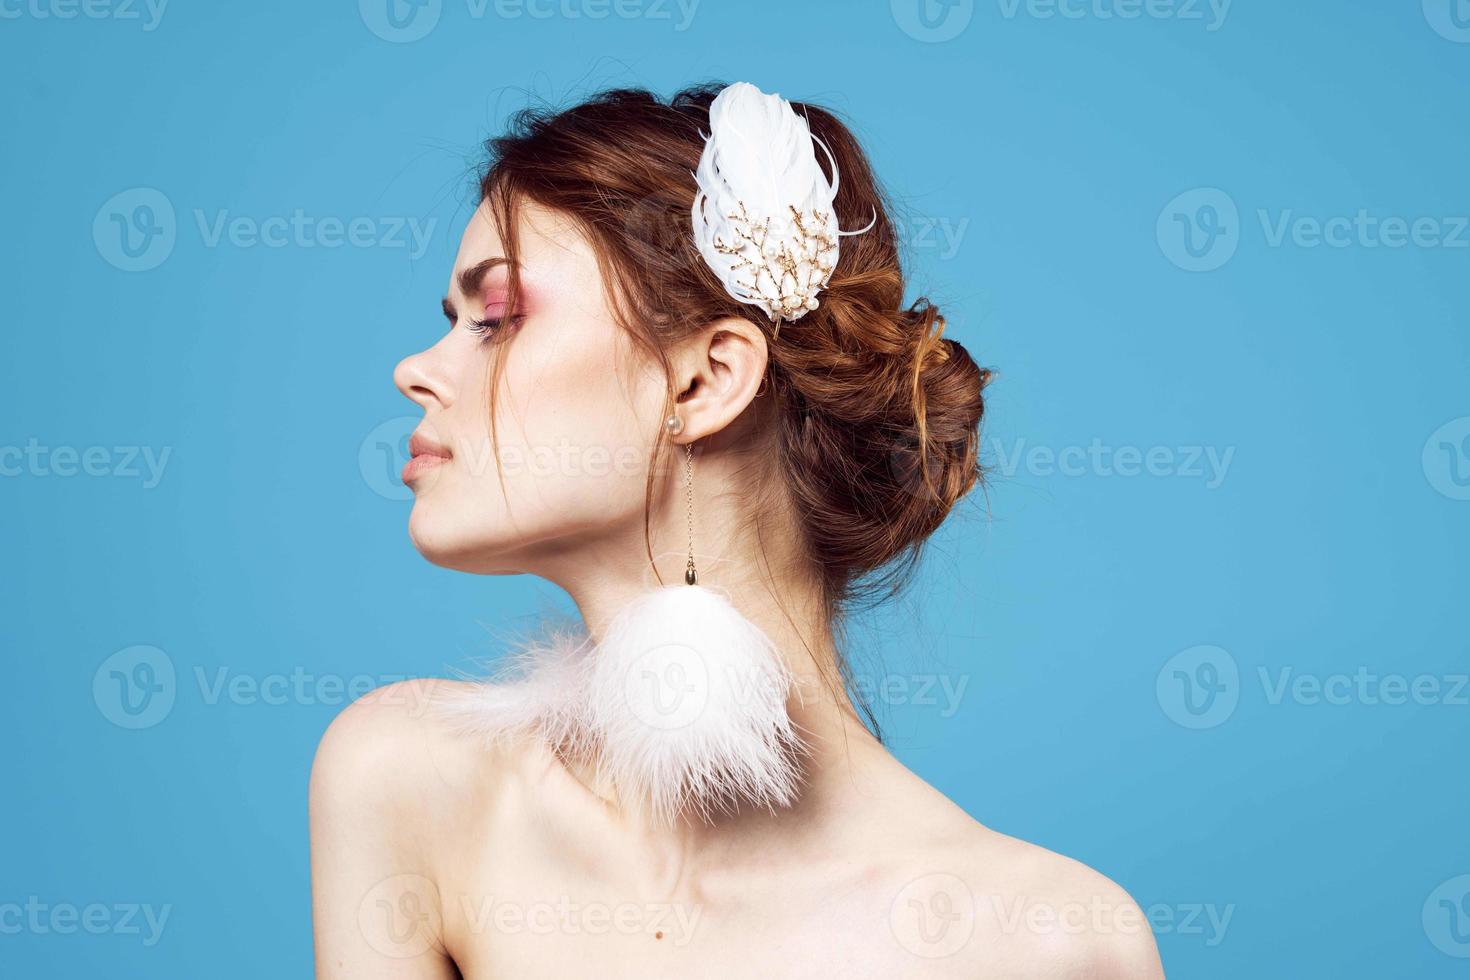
[312, 199, 1163, 980]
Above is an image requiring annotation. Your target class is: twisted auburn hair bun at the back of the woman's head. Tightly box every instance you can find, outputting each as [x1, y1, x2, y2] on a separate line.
[775, 281, 991, 599]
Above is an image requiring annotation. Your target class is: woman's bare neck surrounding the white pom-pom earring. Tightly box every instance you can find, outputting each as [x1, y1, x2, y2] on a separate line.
[534, 434, 883, 873]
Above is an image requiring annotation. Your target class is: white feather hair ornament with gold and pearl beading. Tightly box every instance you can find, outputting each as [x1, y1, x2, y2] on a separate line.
[691, 82, 878, 331]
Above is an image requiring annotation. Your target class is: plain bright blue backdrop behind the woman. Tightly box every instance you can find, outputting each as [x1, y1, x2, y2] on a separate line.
[0, 0, 1470, 977]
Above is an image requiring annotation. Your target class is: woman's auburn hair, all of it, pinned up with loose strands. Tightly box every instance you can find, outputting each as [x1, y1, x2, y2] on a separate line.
[479, 84, 991, 658]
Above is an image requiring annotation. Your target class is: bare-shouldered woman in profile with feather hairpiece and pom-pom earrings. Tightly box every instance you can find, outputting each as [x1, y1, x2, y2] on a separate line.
[312, 84, 1160, 980]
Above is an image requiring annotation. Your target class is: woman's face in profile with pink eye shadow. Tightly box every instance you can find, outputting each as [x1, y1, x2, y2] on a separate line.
[394, 203, 667, 574]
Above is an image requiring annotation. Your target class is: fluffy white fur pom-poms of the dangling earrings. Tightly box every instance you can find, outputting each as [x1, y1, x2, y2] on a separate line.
[438, 583, 804, 826]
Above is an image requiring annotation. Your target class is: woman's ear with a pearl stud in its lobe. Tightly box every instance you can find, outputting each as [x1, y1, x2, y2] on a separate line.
[670, 317, 770, 444]
